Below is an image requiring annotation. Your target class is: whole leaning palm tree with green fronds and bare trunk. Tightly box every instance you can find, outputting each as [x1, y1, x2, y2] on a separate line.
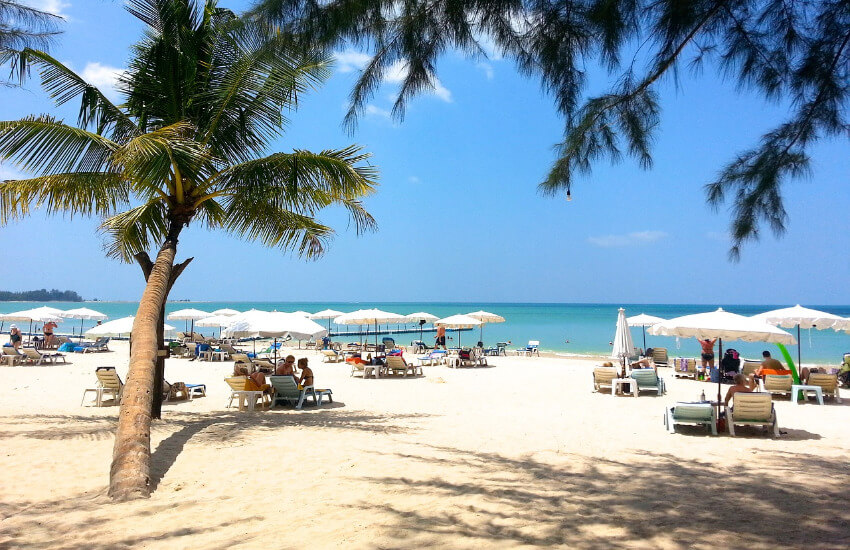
[0, 0, 377, 500]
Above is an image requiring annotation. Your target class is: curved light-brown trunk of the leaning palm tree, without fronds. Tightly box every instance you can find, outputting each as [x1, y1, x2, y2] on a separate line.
[109, 239, 177, 500]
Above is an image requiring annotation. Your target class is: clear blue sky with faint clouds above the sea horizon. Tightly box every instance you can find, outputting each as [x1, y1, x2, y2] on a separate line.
[0, 0, 850, 304]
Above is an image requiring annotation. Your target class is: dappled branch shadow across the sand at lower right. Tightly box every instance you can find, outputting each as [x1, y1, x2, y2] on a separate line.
[350, 446, 850, 549]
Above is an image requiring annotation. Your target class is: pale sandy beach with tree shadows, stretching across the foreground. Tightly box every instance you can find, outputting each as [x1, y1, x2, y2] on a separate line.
[0, 341, 850, 549]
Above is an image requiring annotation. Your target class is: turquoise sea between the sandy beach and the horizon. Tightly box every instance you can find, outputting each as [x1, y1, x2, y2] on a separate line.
[0, 301, 850, 363]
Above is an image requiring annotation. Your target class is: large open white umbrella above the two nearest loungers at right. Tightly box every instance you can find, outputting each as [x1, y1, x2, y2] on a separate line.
[649, 308, 797, 408]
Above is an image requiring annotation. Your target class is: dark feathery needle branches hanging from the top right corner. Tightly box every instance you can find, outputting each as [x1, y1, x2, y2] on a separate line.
[254, 0, 850, 258]
